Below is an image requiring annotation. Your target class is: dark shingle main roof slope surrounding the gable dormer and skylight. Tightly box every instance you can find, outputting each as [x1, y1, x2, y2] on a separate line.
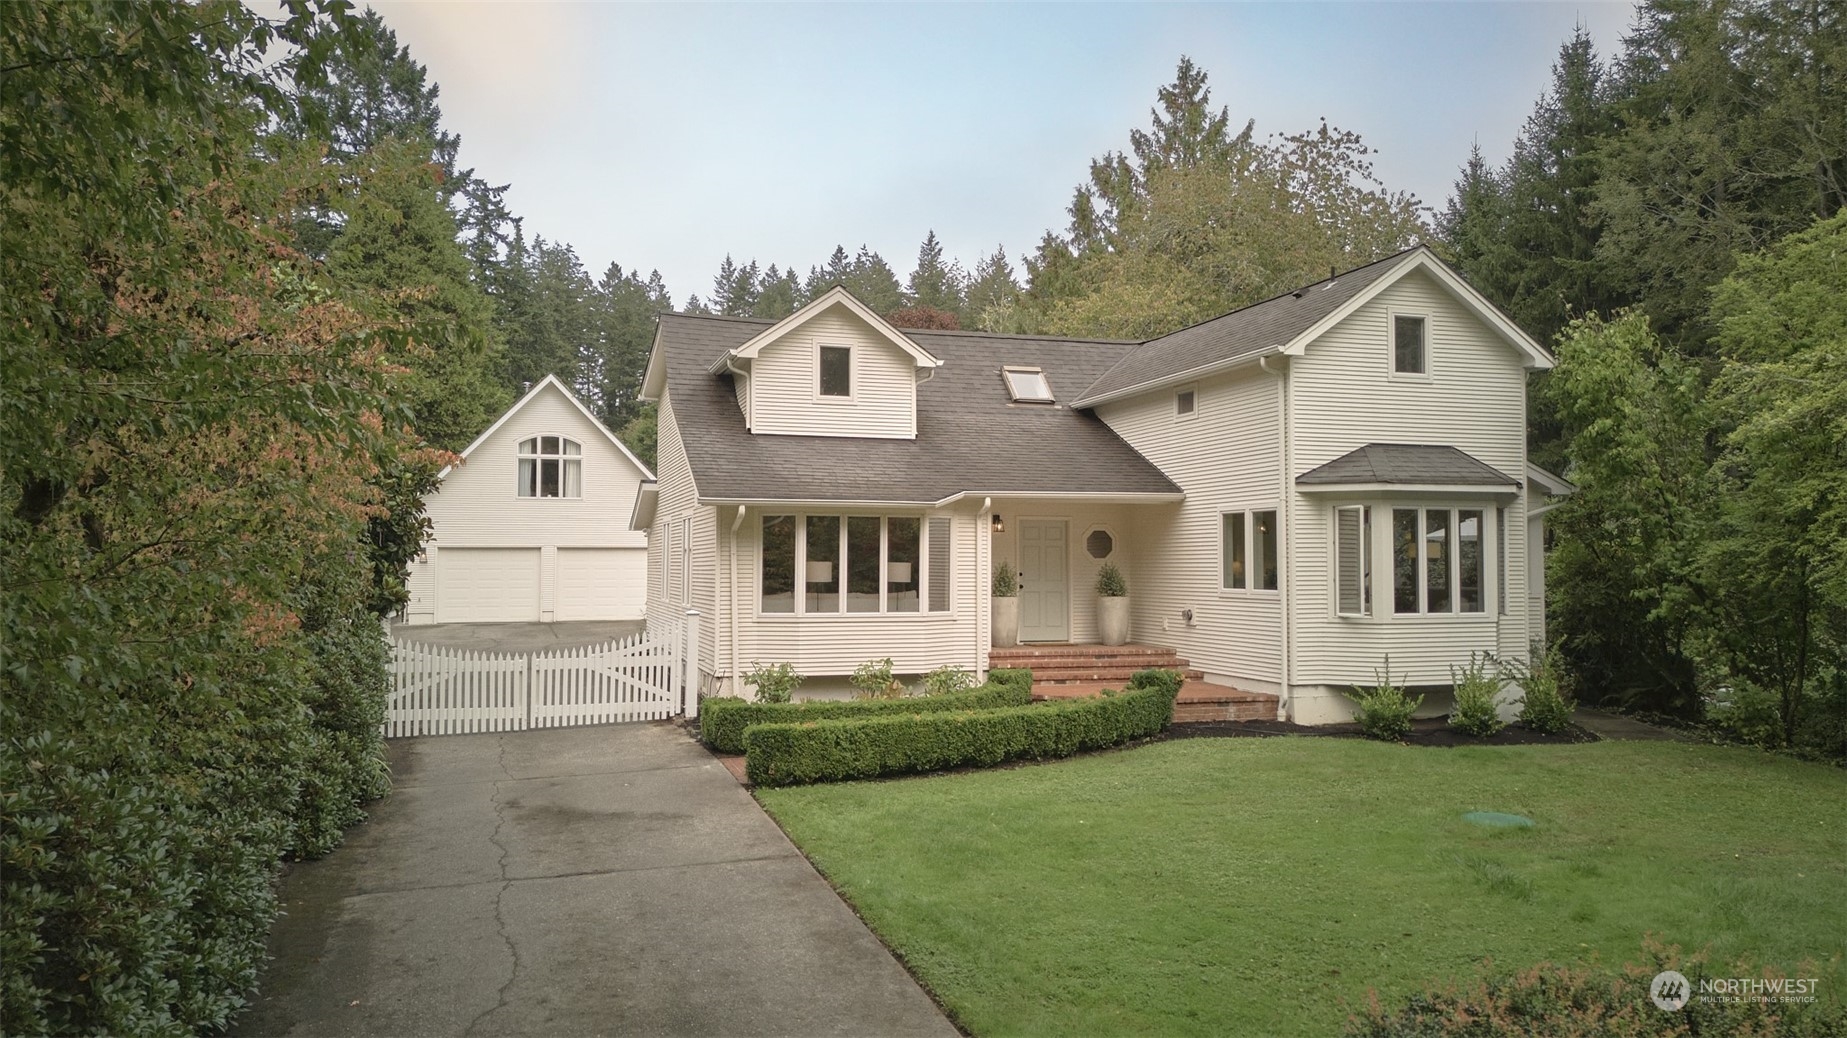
[659, 314, 1180, 502]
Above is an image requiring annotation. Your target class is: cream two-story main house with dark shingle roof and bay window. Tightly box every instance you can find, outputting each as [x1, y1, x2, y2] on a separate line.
[634, 247, 1570, 722]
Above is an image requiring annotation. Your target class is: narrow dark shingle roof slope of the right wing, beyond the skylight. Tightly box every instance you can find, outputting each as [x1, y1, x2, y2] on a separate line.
[1077, 246, 1422, 406]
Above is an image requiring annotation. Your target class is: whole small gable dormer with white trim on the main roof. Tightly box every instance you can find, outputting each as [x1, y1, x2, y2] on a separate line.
[713, 286, 942, 440]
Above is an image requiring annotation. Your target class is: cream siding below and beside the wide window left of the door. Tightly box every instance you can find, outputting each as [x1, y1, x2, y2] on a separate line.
[720, 508, 988, 678]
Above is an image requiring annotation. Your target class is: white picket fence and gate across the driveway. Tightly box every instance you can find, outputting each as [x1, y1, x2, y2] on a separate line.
[384, 610, 698, 739]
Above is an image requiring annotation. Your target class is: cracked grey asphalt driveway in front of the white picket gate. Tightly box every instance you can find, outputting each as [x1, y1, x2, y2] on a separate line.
[231, 722, 957, 1038]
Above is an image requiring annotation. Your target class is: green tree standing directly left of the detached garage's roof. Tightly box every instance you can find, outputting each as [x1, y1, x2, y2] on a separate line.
[327, 142, 508, 451]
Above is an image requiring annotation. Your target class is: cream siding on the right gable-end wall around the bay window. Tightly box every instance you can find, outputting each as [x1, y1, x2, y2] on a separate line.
[1289, 272, 1527, 687]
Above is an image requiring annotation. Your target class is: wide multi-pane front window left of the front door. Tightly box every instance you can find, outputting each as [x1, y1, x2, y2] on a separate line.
[757, 513, 951, 615]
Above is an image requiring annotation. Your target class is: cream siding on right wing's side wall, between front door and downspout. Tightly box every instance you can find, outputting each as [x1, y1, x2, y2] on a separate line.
[1097, 368, 1282, 685]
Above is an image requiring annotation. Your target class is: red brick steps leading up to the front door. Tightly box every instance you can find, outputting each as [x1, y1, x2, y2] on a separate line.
[988, 645, 1276, 724]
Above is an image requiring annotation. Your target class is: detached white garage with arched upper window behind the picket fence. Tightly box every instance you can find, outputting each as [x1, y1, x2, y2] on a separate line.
[404, 377, 654, 624]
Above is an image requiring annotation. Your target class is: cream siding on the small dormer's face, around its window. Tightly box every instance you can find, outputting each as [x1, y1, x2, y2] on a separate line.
[744, 307, 916, 440]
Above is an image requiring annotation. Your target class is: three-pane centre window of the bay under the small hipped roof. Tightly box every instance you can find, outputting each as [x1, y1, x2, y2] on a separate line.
[1391, 506, 1487, 615]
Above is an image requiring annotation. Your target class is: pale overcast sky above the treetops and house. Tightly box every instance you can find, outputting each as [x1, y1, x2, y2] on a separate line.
[375, 0, 1633, 305]
